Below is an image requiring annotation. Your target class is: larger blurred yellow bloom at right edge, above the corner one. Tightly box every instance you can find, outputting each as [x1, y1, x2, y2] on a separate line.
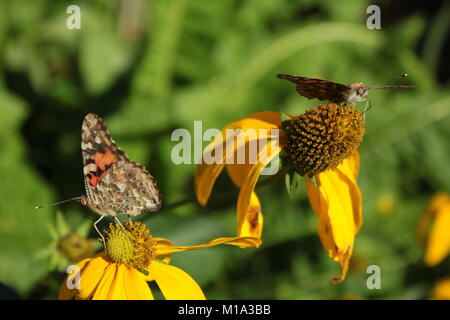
[417, 193, 450, 267]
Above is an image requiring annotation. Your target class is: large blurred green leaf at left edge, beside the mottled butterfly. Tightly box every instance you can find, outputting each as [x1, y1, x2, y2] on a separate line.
[0, 88, 51, 294]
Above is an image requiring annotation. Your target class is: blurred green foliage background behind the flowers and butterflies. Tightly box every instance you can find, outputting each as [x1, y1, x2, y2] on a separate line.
[0, 0, 450, 299]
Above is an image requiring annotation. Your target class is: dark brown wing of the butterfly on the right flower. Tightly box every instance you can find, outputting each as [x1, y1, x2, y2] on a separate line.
[277, 74, 352, 103]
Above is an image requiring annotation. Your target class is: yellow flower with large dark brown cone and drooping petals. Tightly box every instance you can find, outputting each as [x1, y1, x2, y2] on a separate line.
[195, 103, 365, 283]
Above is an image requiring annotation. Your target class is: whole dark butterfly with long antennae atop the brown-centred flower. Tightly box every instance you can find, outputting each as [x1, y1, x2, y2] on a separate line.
[277, 74, 414, 104]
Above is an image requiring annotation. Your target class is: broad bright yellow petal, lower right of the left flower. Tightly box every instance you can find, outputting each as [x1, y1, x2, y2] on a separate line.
[148, 261, 206, 300]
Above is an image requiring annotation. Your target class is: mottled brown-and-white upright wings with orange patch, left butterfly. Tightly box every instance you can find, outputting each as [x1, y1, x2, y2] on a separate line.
[81, 113, 161, 215]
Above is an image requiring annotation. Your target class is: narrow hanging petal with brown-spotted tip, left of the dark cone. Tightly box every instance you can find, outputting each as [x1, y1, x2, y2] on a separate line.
[237, 141, 281, 236]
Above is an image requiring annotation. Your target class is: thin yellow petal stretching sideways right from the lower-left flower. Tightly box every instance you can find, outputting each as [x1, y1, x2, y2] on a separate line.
[153, 237, 261, 259]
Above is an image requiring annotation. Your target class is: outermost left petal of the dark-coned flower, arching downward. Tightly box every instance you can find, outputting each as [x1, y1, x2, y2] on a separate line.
[194, 111, 281, 206]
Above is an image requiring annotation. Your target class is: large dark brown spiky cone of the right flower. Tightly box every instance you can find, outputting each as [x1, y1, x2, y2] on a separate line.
[284, 103, 365, 177]
